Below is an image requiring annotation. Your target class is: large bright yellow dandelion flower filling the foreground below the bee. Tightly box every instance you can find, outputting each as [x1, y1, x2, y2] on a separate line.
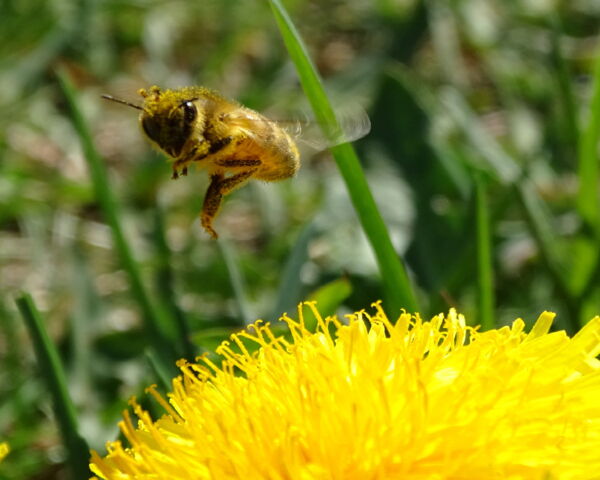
[91, 302, 600, 480]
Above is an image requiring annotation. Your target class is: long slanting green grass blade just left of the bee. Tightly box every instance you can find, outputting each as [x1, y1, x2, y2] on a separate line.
[57, 72, 177, 371]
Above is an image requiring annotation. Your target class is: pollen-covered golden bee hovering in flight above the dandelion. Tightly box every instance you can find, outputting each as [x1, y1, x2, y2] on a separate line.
[103, 86, 370, 239]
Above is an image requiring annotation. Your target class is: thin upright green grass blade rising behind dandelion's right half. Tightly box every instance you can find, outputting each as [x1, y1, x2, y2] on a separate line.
[475, 176, 496, 330]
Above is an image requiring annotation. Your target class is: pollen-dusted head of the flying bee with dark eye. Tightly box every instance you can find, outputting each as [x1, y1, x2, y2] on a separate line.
[139, 86, 198, 158]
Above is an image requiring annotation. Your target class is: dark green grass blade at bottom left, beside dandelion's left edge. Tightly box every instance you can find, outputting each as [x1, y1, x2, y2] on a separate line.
[16, 294, 90, 480]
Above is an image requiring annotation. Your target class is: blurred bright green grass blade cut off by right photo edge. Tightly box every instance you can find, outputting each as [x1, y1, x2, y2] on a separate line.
[577, 55, 600, 233]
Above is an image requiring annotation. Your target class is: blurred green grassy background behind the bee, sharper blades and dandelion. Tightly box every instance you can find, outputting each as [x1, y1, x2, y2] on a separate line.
[0, 0, 600, 480]
